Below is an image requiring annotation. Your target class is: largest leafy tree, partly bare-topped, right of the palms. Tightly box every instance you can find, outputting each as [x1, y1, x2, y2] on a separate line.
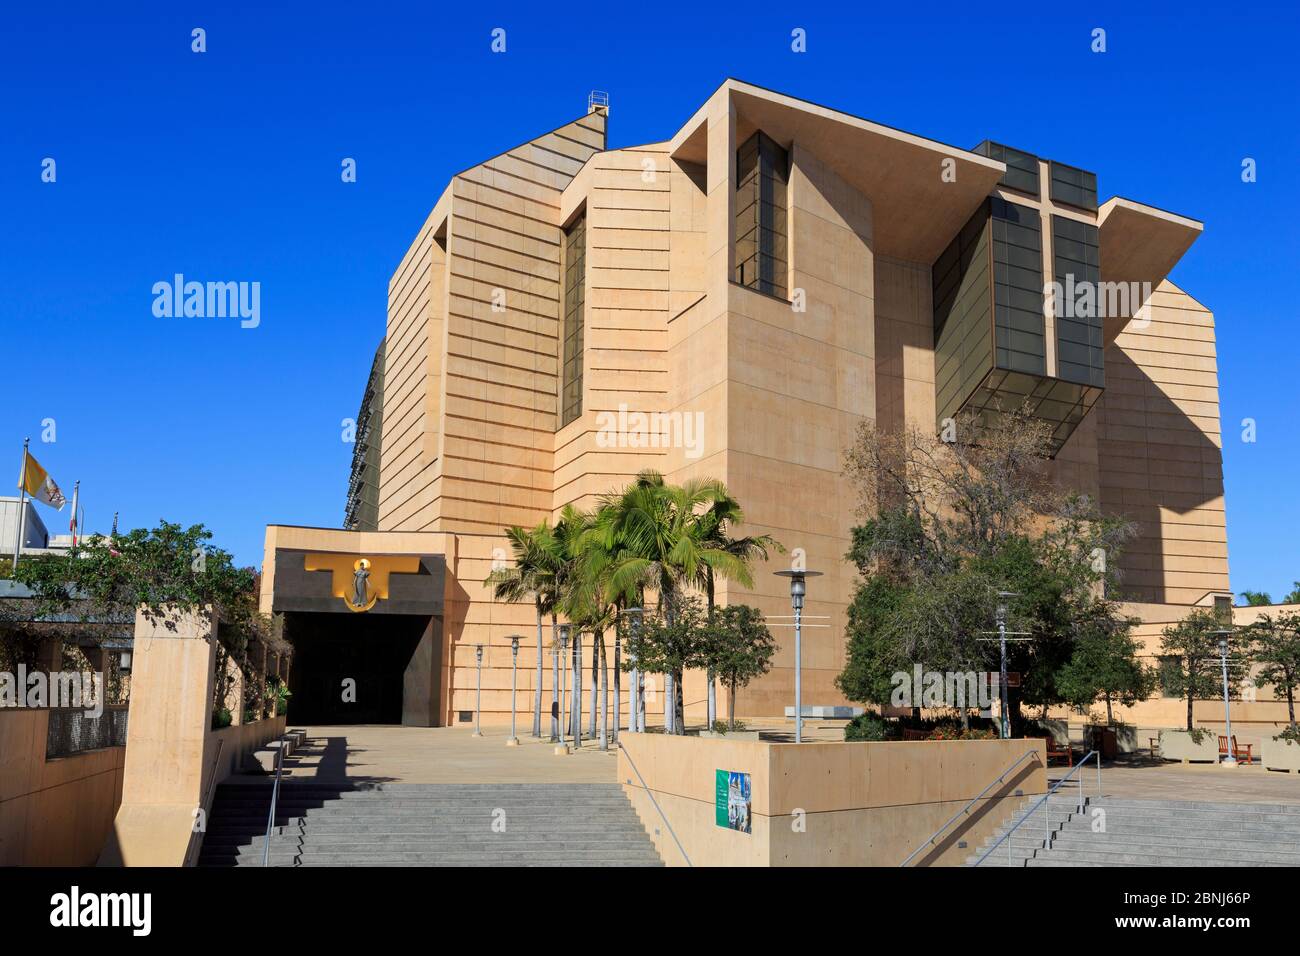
[840, 408, 1132, 728]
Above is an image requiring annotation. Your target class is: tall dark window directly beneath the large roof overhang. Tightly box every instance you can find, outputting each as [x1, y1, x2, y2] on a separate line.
[736, 133, 789, 299]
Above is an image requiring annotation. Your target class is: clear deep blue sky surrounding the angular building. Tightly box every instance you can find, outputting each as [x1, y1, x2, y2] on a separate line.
[0, 0, 1300, 597]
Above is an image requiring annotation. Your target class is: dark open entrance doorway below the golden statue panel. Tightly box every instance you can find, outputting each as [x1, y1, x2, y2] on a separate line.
[285, 611, 441, 724]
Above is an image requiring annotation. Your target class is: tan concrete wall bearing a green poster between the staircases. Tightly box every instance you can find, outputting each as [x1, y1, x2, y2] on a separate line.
[619, 734, 1047, 866]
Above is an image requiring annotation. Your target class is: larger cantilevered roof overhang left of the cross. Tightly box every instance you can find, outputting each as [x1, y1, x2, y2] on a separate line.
[672, 79, 1006, 264]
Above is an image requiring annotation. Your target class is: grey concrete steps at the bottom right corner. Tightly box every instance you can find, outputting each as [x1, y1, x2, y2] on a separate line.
[966, 793, 1300, 866]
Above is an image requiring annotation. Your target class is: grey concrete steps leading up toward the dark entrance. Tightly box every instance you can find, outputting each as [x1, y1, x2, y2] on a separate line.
[199, 780, 663, 866]
